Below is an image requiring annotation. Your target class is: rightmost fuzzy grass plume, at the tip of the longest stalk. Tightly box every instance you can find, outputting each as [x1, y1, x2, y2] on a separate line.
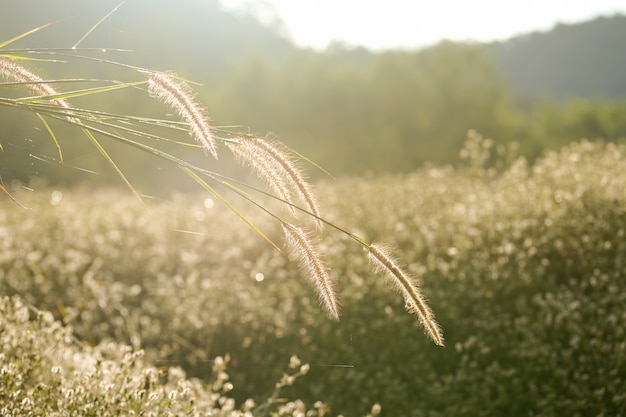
[368, 244, 443, 346]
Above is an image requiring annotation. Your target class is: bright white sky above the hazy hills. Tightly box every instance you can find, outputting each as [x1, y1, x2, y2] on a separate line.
[222, 0, 626, 50]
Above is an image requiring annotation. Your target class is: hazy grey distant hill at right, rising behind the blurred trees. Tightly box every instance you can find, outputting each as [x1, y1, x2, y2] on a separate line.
[488, 14, 626, 100]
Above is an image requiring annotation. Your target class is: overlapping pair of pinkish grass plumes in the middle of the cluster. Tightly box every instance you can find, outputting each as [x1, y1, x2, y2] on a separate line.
[227, 135, 324, 229]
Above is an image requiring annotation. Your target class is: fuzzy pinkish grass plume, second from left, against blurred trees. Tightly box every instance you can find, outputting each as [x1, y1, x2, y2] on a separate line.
[148, 72, 217, 159]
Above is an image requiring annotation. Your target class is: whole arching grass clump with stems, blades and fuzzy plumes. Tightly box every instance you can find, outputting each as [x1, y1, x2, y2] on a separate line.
[0, 25, 443, 346]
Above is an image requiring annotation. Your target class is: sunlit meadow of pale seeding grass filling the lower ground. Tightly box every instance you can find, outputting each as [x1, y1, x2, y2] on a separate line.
[0, 134, 626, 416]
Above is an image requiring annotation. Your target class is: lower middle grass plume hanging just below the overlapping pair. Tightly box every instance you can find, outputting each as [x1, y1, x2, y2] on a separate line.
[282, 222, 339, 321]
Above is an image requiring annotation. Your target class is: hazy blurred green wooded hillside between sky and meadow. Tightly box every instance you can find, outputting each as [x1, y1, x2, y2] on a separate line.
[0, 0, 626, 188]
